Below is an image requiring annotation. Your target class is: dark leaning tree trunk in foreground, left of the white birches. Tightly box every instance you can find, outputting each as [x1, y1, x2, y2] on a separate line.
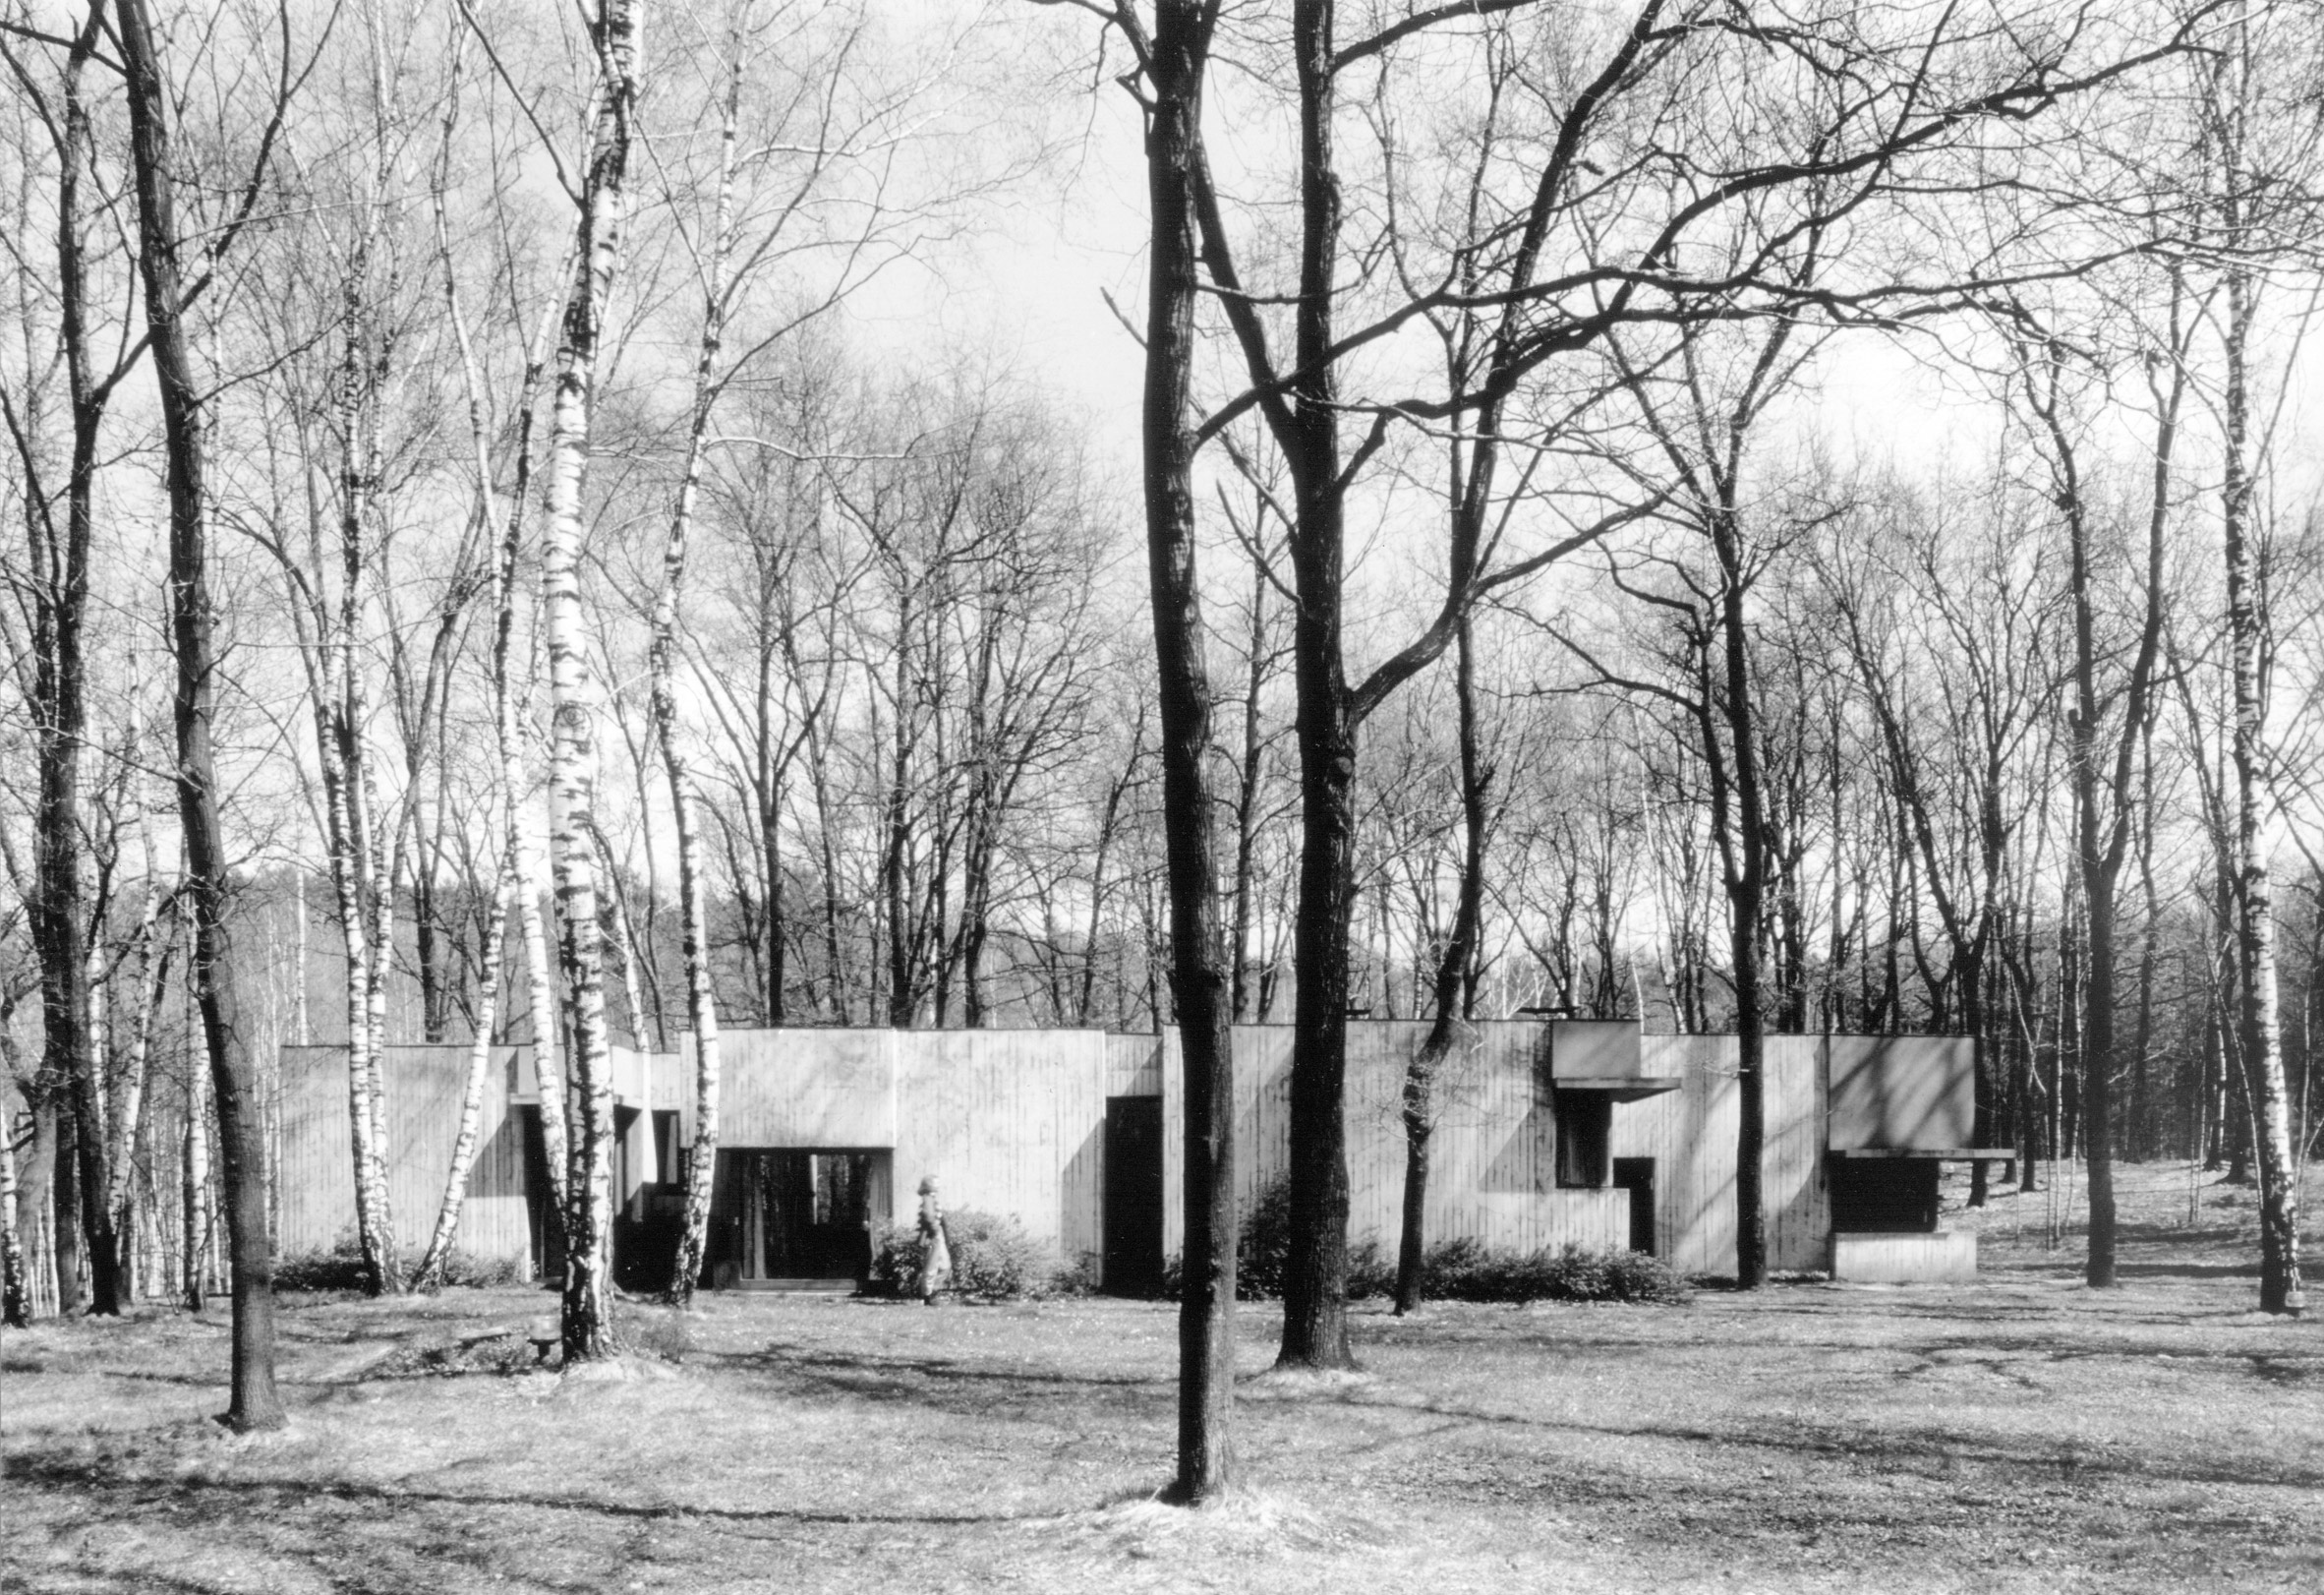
[114, 0, 283, 1432]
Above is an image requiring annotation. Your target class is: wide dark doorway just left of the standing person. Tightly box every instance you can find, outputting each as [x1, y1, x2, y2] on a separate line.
[709, 1147, 890, 1286]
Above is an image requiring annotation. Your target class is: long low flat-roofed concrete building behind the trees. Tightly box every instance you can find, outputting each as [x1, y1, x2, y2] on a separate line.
[276, 1021, 1980, 1293]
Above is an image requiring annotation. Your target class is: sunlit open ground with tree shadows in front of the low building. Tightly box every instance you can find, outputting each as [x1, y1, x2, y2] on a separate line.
[0, 1165, 2324, 1595]
